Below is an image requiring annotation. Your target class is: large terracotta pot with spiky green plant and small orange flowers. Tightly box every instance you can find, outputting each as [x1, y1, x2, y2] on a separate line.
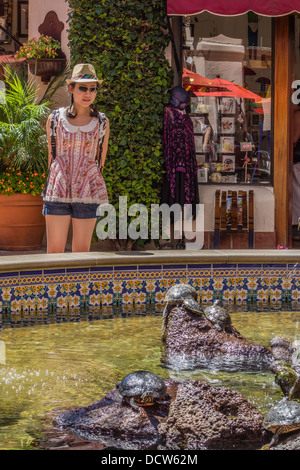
[0, 68, 50, 250]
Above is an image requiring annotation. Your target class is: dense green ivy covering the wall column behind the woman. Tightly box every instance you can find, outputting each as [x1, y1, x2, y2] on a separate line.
[68, 0, 173, 248]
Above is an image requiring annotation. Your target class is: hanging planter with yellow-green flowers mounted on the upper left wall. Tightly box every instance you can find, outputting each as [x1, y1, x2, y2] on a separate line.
[15, 34, 66, 83]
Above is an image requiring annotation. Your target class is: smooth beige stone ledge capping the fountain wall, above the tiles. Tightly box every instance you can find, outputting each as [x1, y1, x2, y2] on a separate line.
[0, 250, 300, 273]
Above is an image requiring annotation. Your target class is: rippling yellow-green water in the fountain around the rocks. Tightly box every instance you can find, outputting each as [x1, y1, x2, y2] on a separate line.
[0, 311, 300, 450]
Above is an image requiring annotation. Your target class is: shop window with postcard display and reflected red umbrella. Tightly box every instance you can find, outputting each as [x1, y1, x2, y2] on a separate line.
[183, 12, 272, 185]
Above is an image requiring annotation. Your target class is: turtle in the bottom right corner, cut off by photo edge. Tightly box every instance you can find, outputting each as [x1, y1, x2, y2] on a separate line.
[263, 397, 300, 450]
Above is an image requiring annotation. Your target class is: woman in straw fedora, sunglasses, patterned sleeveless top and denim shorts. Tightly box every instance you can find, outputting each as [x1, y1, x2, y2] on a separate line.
[42, 64, 109, 253]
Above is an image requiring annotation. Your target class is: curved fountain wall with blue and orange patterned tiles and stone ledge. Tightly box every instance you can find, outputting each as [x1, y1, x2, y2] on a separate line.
[0, 250, 300, 312]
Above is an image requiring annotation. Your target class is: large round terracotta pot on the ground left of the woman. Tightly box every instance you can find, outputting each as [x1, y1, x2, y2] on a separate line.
[0, 193, 45, 251]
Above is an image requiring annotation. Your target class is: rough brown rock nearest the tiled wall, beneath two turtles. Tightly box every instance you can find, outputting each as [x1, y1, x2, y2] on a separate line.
[163, 292, 272, 372]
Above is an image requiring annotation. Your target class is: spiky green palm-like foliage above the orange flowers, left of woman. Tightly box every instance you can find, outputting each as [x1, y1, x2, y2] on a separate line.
[0, 67, 50, 174]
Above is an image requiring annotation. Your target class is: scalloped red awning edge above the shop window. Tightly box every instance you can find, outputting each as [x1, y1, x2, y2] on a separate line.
[167, 0, 300, 16]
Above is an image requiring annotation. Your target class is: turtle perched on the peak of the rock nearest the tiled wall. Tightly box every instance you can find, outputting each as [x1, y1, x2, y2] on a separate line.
[162, 283, 203, 340]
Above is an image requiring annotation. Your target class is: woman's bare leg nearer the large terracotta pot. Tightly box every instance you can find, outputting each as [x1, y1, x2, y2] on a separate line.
[45, 215, 71, 253]
